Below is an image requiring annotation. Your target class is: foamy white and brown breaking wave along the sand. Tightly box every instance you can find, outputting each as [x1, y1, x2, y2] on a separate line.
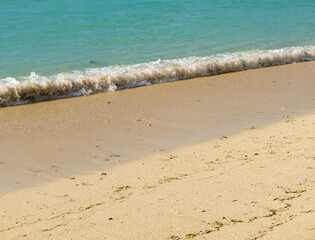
[0, 46, 315, 107]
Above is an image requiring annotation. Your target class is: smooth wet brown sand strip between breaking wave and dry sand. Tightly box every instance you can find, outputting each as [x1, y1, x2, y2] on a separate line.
[0, 62, 315, 193]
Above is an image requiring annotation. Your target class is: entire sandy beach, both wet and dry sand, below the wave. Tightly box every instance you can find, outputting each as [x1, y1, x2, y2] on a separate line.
[0, 62, 315, 239]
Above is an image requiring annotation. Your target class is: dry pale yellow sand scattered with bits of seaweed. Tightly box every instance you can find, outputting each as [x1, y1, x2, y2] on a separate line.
[0, 115, 315, 239]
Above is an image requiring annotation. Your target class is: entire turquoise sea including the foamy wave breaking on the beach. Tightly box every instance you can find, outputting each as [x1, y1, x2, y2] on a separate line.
[0, 0, 315, 106]
